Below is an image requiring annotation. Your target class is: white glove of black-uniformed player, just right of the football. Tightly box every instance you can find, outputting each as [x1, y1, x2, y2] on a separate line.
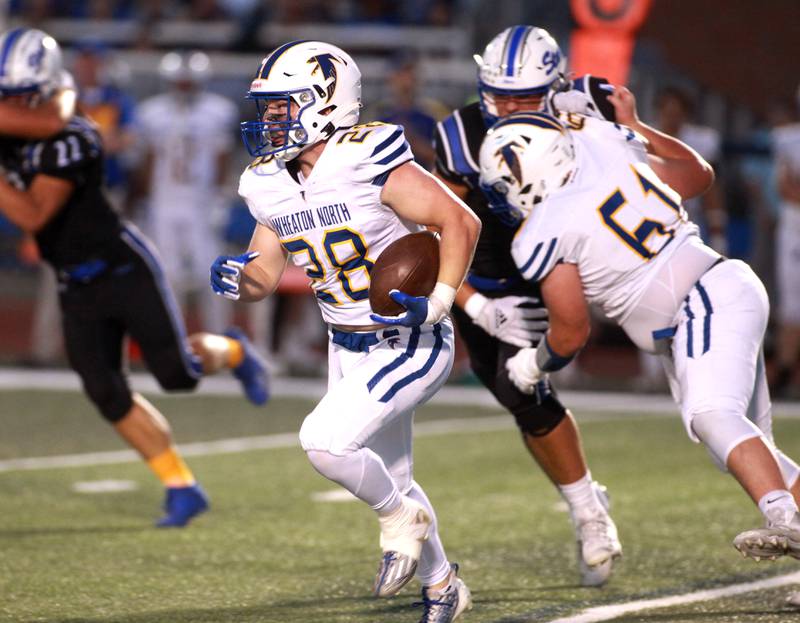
[464, 292, 548, 348]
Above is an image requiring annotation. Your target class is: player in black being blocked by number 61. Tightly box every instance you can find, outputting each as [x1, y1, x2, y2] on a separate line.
[435, 26, 622, 586]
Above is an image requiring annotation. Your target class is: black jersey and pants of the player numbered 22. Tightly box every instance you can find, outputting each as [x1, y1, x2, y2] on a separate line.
[0, 116, 200, 422]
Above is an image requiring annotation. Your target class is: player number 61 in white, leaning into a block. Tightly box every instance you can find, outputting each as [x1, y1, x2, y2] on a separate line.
[480, 87, 800, 560]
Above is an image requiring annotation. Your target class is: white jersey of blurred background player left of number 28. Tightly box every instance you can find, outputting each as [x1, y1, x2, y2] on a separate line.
[137, 92, 238, 204]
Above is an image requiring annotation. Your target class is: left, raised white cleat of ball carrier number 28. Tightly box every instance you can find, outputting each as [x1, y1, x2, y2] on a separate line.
[373, 496, 432, 597]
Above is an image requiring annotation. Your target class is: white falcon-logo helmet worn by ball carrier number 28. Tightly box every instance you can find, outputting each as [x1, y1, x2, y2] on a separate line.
[241, 41, 361, 160]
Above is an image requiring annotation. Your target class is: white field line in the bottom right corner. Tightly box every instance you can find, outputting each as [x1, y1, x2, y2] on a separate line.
[544, 571, 800, 623]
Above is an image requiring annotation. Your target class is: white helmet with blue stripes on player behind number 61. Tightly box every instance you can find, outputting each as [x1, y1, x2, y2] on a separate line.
[474, 26, 567, 124]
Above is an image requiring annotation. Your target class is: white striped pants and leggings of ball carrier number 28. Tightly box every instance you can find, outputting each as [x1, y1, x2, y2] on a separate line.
[300, 319, 453, 585]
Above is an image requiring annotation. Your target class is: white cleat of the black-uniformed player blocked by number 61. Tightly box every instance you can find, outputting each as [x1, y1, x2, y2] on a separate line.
[575, 483, 622, 586]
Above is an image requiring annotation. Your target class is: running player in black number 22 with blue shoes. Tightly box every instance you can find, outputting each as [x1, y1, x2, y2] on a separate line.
[0, 28, 267, 527]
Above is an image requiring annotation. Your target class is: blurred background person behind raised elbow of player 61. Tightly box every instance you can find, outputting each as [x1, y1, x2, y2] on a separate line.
[656, 87, 727, 253]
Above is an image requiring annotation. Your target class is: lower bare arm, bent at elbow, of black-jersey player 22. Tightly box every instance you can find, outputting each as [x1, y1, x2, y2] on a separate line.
[0, 174, 74, 234]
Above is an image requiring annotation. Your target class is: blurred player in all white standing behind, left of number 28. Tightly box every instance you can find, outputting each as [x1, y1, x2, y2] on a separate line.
[138, 52, 238, 332]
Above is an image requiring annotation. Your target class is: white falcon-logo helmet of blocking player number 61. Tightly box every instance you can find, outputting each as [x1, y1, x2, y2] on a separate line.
[480, 112, 576, 225]
